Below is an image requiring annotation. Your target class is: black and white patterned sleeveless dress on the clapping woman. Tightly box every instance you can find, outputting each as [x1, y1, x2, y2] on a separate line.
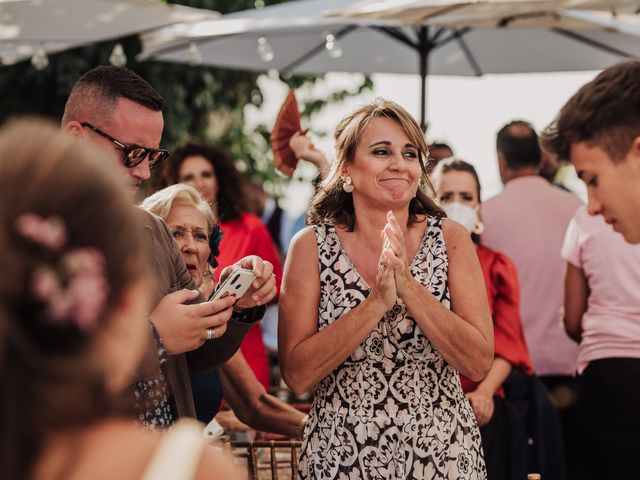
[299, 218, 486, 480]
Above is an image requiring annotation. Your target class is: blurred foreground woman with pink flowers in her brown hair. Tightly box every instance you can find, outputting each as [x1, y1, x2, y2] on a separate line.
[0, 121, 238, 480]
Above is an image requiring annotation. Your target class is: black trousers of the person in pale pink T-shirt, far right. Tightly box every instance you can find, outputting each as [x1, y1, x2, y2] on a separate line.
[576, 358, 640, 480]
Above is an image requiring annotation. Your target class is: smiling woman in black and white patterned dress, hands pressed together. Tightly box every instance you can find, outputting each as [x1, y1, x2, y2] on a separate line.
[279, 100, 493, 479]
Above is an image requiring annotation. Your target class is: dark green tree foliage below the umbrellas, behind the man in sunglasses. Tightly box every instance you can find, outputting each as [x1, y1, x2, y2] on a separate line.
[0, 0, 372, 195]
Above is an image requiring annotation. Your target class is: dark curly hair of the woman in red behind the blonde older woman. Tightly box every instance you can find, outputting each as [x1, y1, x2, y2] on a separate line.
[163, 142, 249, 222]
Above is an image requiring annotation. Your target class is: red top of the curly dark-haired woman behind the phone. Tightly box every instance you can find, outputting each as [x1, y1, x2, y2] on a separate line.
[214, 213, 282, 390]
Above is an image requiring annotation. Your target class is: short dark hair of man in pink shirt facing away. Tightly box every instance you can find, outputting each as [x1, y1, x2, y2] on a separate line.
[496, 120, 542, 170]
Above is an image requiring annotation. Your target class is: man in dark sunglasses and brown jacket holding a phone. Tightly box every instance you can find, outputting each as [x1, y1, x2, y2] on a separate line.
[62, 67, 275, 429]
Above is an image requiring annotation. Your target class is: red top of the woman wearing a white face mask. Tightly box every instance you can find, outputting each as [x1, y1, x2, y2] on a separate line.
[460, 245, 533, 394]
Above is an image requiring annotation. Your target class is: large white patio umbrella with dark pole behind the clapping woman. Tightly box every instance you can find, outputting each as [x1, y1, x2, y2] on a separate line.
[139, 0, 640, 128]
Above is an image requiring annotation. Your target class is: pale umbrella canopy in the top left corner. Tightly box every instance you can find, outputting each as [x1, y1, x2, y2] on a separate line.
[0, 0, 218, 65]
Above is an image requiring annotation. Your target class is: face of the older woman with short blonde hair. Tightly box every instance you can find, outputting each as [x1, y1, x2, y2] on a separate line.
[165, 202, 211, 287]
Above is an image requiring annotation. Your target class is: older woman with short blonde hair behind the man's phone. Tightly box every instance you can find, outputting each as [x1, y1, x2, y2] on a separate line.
[141, 183, 305, 438]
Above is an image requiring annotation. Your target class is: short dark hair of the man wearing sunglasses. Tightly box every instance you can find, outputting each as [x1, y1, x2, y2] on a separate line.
[62, 66, 164, 125]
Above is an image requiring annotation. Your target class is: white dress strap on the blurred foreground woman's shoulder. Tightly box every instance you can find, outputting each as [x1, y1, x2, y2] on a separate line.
[140, 418, 205, 480]
